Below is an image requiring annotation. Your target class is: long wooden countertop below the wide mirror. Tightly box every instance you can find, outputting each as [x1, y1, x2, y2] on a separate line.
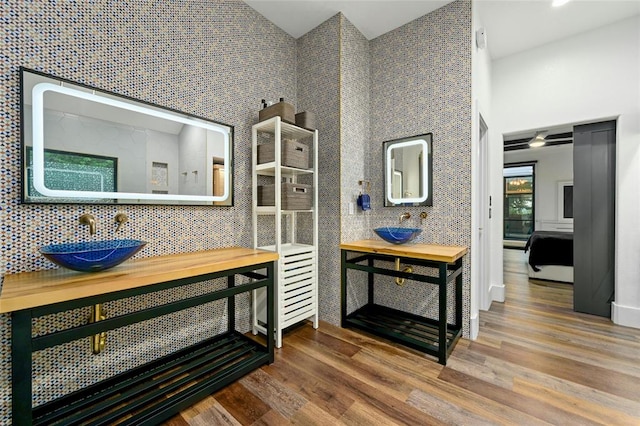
[0, 247, 278, 313]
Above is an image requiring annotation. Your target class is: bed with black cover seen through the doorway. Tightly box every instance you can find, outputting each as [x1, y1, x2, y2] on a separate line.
[524, 231, 573, 283]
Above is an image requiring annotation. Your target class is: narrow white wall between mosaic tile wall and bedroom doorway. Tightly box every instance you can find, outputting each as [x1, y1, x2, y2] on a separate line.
[470, 2, 496, 339]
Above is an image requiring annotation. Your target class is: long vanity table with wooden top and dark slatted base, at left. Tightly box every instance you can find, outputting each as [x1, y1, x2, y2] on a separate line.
[0, 247, 278, 426]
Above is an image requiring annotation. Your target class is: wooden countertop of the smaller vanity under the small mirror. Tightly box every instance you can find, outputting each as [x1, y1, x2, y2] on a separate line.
[340, 240, 467, 263]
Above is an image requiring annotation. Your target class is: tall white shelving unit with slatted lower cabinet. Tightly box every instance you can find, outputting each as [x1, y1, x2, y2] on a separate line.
[251, 117, 318, 348]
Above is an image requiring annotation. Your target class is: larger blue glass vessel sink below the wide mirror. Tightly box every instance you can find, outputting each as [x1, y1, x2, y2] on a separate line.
[40, 240, 147, 272]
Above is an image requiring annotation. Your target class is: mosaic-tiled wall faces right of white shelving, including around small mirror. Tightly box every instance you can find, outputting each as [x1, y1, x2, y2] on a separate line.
[298, 0, 471, 336]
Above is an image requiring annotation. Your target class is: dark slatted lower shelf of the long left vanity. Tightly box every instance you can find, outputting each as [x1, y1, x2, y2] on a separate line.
[33, 331, 269, 425]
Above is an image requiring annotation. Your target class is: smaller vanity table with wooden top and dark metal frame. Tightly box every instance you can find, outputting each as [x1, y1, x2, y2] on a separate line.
[340, 240, 467, 365]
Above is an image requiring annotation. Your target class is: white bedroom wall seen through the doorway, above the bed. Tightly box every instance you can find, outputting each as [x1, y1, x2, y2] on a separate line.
[504, 144, 573, 230]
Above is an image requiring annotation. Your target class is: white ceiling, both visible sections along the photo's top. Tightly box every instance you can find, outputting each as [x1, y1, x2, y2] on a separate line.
[245, 0, 640, 59]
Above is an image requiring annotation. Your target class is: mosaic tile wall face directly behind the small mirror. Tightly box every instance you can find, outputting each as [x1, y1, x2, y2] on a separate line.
[369, 0, 472, 337]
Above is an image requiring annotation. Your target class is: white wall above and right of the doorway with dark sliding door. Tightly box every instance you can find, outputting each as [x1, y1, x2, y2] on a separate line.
[492, 16, 640, 328]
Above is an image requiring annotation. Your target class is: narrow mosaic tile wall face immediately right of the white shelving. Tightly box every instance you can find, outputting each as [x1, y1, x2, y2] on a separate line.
[298, 15, 341, 324]
